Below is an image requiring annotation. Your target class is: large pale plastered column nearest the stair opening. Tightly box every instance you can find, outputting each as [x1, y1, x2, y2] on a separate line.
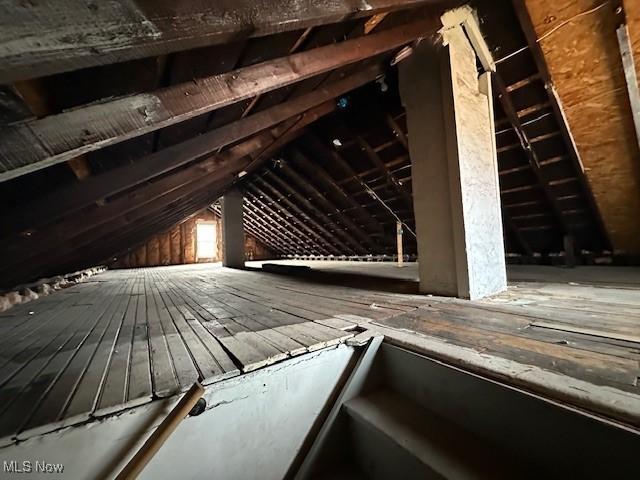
[400, 9, 506, 299]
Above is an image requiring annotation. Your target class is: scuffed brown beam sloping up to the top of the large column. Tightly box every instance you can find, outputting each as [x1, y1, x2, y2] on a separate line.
[0, 19, 437, 182]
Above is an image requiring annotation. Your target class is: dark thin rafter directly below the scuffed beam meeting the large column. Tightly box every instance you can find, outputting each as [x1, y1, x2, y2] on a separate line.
[2, 67, 380, 236]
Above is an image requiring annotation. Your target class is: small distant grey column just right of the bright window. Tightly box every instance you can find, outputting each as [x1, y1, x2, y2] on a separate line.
[220, 188, 244, 268]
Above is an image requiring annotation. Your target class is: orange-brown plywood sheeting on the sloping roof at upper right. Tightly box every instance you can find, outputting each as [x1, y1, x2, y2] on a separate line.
[525, 0, 640, 253]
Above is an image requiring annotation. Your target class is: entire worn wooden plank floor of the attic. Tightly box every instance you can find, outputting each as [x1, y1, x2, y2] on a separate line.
[0, 263, 640, 442]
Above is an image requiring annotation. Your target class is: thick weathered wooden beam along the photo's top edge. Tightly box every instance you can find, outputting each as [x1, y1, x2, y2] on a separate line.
[0, 0, 442, 83]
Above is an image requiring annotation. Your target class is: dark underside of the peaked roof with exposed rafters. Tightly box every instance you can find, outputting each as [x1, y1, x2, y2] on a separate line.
[0, 0, 608, 288]
